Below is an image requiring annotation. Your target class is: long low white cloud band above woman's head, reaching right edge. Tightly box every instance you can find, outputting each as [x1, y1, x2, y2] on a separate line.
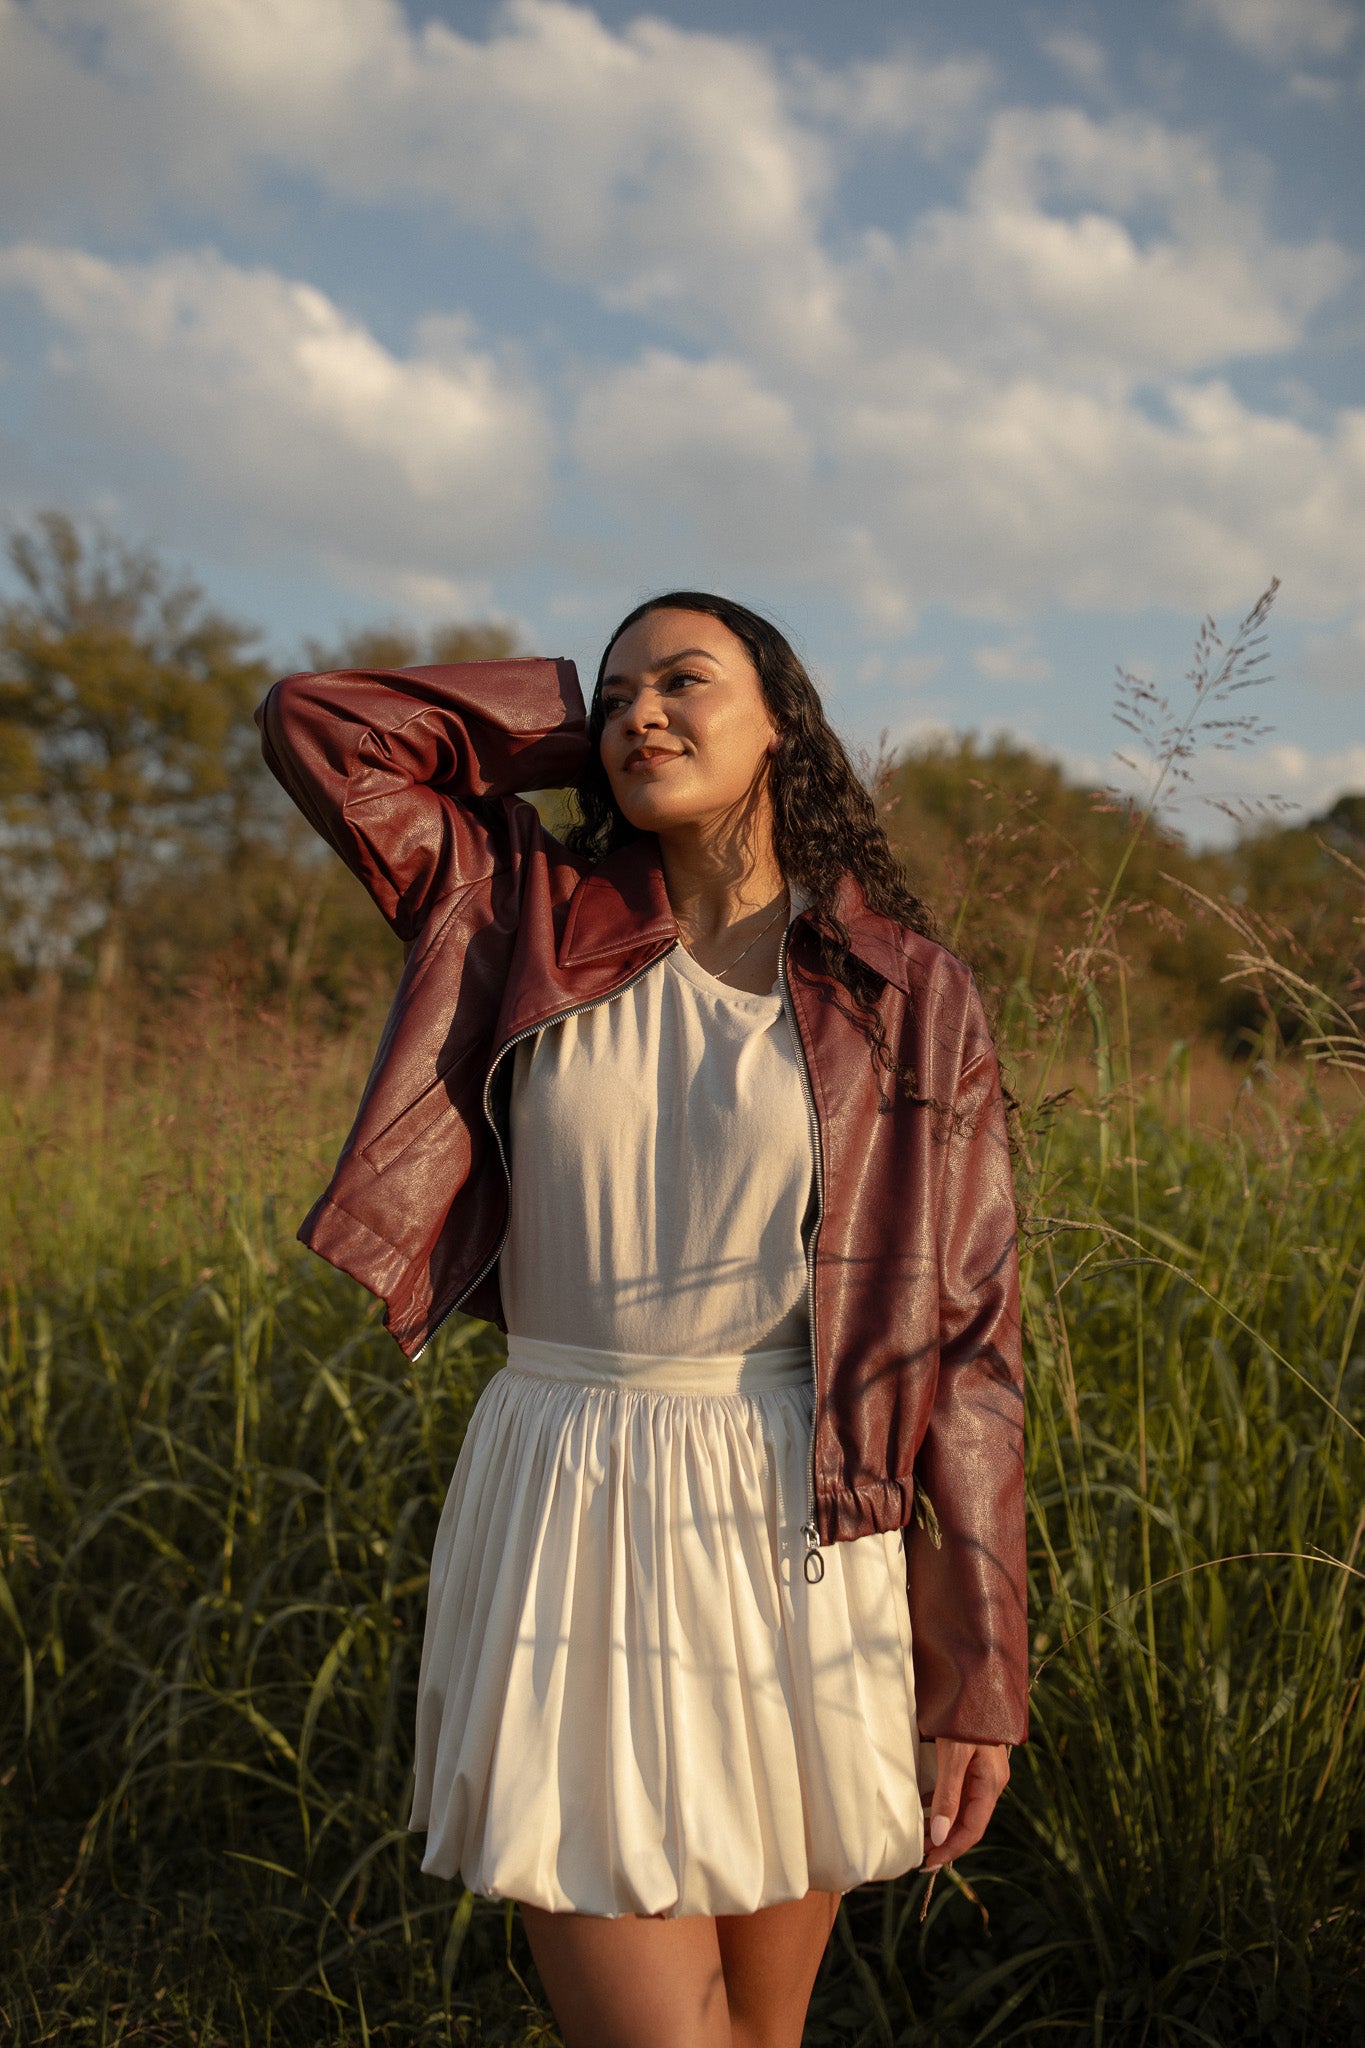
[556, 331, 1365, 622]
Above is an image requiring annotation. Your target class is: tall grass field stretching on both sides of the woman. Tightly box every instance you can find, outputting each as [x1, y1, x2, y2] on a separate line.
[0, 993, 1365, 2048]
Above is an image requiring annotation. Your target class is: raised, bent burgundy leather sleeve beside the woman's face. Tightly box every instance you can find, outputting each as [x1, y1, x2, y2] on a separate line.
[256, 659, 587, 940]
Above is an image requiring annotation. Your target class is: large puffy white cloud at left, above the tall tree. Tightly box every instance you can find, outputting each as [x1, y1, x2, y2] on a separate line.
[0, 244, 548, 580]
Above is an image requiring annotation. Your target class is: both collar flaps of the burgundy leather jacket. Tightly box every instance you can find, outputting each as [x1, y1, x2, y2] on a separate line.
[559, 834, 911, 995]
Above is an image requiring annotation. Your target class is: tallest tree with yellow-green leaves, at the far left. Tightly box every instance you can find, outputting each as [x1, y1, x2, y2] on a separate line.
[0, 512, 266, 987]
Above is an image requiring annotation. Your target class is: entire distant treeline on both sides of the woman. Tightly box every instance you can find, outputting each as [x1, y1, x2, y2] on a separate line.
[0, 512, 1365, 1055]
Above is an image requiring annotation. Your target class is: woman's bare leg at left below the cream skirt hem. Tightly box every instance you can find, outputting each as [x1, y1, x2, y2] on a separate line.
[522, 1905, 736, 2048]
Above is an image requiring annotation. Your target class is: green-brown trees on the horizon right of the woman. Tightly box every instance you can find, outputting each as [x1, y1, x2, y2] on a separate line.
[882, 737, 1365, 1057]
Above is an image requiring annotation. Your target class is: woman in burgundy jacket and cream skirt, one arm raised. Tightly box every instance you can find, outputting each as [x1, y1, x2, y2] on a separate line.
[258, 592, 1025, 2048]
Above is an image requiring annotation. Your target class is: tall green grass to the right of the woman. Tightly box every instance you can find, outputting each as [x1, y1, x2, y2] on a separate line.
[833, 1089, 1365, 2044]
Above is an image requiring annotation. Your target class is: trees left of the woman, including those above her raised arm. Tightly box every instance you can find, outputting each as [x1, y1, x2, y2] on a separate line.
[0, 512, 516, 1020]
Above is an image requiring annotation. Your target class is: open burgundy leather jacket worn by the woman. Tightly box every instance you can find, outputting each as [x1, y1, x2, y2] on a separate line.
[256, 659, 1027, 1743]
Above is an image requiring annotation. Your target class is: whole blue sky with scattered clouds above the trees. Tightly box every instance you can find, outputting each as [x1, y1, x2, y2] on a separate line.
[0, 0, 1365, 838]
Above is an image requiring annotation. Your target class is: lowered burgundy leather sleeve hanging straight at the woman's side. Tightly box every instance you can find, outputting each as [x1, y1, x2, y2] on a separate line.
[907, 987, 1027, 1743]
